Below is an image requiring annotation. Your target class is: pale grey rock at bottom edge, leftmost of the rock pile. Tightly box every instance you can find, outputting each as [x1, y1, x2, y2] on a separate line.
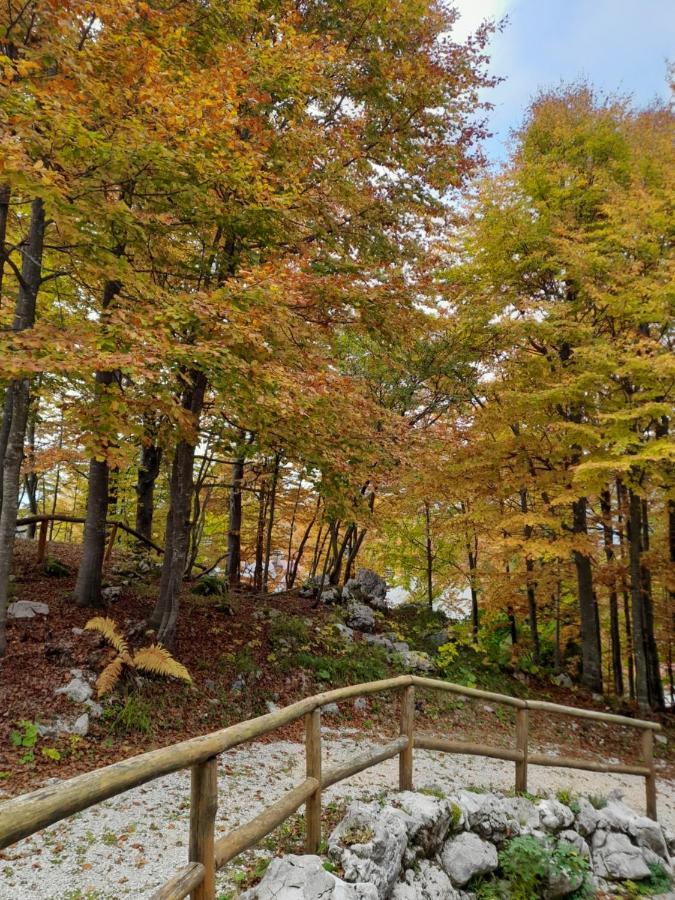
[241, 855, 378, 900]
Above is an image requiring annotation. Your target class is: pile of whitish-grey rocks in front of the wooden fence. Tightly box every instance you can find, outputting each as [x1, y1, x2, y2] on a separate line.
[244, 789, 672, 900]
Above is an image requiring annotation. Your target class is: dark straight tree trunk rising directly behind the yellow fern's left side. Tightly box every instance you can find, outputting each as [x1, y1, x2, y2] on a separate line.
[73, 281, 121, 608]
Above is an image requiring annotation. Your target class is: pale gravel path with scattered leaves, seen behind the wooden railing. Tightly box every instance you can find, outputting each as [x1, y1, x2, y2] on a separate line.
[0, 729, 675, 900]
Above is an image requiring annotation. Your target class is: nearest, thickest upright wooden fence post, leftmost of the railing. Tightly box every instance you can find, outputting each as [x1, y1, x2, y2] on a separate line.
[190, 756, 218, 900]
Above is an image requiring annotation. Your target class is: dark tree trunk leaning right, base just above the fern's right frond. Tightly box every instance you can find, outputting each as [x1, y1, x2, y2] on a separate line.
[150, 371, 206, 649]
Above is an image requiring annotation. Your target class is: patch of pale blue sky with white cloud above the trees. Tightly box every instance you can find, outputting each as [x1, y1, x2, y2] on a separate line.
[454, 0, 675, 161]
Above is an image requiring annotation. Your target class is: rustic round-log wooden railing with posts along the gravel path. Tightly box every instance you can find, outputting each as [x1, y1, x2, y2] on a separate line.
[0, 675, 660, 900]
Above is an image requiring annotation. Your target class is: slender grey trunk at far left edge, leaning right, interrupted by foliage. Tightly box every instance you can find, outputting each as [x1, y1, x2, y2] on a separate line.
[0, 199, 45, 656]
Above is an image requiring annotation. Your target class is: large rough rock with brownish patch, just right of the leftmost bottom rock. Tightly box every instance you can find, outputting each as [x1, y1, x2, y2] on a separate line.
[328, 801, 408, 900]
